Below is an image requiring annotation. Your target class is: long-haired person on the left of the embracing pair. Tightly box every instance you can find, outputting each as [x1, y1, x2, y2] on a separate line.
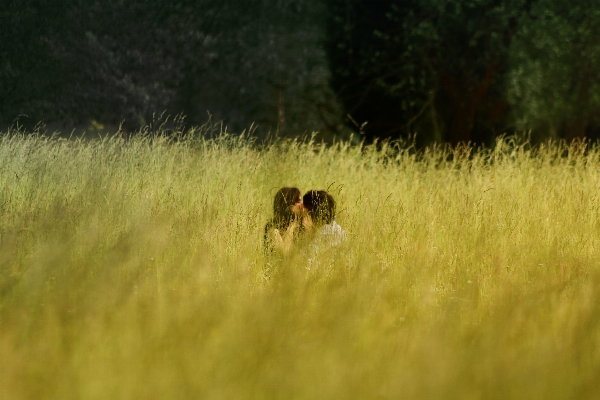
[263, 187, 306, 253]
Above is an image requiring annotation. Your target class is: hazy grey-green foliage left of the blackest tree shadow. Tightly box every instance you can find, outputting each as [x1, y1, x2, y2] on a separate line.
[0, 0, 342, 135]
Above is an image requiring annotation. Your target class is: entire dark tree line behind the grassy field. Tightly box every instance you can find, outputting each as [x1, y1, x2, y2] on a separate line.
[0, 0, 600, 145]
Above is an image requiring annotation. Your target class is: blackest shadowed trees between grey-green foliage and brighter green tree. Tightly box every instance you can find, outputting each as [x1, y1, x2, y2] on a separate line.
[329, 0, 530, 143]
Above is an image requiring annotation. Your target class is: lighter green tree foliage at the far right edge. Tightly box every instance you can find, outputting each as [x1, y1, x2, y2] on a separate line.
[507, 0, 600, 138]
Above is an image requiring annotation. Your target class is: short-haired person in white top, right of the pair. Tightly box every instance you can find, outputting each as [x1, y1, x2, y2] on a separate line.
[302, 190, 347, 250]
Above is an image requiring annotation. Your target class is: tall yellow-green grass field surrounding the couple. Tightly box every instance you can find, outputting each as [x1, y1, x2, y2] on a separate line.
[0, 126, 600, 400]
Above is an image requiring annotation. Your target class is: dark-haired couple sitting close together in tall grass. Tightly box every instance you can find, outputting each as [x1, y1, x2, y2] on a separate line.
[264, 187, 347, 254]
